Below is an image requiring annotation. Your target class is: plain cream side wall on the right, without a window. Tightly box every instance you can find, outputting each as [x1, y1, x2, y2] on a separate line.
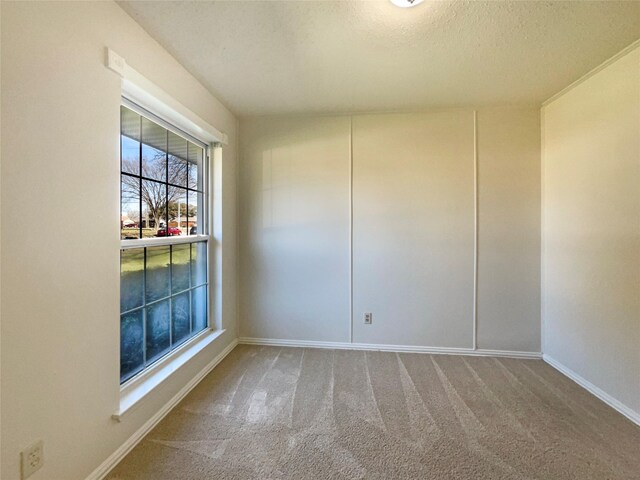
[543, 48, 640, 420]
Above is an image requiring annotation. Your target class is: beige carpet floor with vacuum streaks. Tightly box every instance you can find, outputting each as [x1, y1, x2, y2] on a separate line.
[108, 346, 640, 480]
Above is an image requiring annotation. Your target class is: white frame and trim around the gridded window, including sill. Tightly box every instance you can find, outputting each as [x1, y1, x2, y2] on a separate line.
[106, 48, 228, 421]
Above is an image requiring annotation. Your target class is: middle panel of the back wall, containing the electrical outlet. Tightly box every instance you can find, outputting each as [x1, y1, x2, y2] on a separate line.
[353, 111, 474, 348]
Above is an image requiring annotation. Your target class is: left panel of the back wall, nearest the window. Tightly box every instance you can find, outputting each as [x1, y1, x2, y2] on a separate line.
[240, 117, 349, 341]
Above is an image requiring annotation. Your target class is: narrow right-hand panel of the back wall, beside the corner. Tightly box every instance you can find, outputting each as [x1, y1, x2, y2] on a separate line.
[478, 108, 540, 351]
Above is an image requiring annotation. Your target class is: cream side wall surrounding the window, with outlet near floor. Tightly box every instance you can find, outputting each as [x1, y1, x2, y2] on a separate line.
[0, 2, 237, 480]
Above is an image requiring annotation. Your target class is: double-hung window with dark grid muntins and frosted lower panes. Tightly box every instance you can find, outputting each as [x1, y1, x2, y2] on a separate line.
[120, 100, 209, 383]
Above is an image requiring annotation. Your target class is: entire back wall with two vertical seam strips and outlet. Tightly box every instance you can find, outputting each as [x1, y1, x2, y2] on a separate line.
[239, 108, 540, 352]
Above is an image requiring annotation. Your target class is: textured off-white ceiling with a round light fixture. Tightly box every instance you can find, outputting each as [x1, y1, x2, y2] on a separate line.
[119, 0, 640, 116]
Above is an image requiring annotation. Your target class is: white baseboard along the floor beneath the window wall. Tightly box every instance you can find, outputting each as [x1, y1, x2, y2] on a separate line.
[86, 339, 238, 480]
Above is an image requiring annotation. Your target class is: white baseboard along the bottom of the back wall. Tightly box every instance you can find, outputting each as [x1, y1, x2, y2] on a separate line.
[239, 337, 542, 359]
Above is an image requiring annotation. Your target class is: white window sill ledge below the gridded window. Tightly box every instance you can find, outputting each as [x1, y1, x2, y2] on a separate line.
[111, 330, 224, 422]
